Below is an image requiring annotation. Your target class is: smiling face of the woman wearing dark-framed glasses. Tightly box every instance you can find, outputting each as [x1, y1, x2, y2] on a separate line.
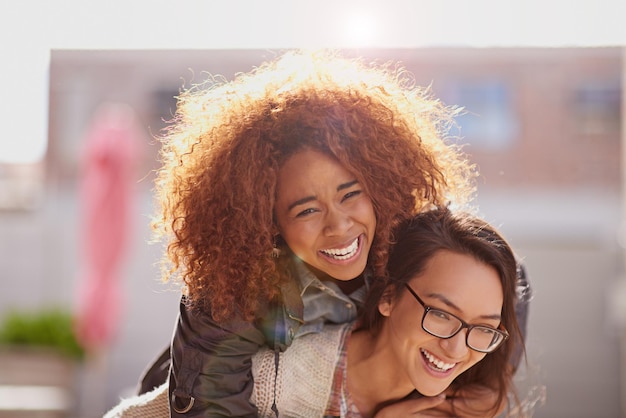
[379, 250, 503, 396]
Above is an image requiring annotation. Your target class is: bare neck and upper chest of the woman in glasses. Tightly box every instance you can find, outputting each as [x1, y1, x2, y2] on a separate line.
[347, 330, 415, 417]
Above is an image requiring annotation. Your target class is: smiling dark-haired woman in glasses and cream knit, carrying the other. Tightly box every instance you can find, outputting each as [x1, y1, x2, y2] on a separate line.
[253, 209, 523, 417]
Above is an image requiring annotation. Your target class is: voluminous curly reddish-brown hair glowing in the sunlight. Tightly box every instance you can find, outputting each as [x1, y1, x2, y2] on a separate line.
[153, 51, 475, 320]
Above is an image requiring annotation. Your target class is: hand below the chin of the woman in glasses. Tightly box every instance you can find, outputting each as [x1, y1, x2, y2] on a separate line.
[426, 384, 506, 418]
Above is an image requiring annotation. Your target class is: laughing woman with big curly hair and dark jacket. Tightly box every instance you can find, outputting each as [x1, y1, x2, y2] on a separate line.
[136, 51, 520, 417]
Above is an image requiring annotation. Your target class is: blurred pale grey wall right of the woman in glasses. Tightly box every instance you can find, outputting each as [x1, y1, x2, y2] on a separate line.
[479, 190, 626, 418]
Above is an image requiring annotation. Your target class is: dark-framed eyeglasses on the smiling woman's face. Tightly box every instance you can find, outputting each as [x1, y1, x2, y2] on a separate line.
[404, 283, 509, 353]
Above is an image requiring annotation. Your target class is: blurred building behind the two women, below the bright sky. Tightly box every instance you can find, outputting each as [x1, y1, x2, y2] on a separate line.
[0, 48, 626, 418]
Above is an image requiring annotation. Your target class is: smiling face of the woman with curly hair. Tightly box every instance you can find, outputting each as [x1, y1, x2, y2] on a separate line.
[275, 150, 376, 281]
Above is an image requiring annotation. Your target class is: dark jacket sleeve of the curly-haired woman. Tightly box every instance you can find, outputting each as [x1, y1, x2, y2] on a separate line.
[169, 302, 265, 418]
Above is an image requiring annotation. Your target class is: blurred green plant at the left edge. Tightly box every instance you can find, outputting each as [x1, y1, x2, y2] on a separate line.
[0, 308, 85, 359]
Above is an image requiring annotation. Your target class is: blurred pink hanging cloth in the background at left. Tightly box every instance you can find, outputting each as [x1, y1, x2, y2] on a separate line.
[76, 103, 141, 350]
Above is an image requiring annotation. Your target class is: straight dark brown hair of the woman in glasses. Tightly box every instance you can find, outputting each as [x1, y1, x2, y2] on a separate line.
[361, 208, 524, 414]
